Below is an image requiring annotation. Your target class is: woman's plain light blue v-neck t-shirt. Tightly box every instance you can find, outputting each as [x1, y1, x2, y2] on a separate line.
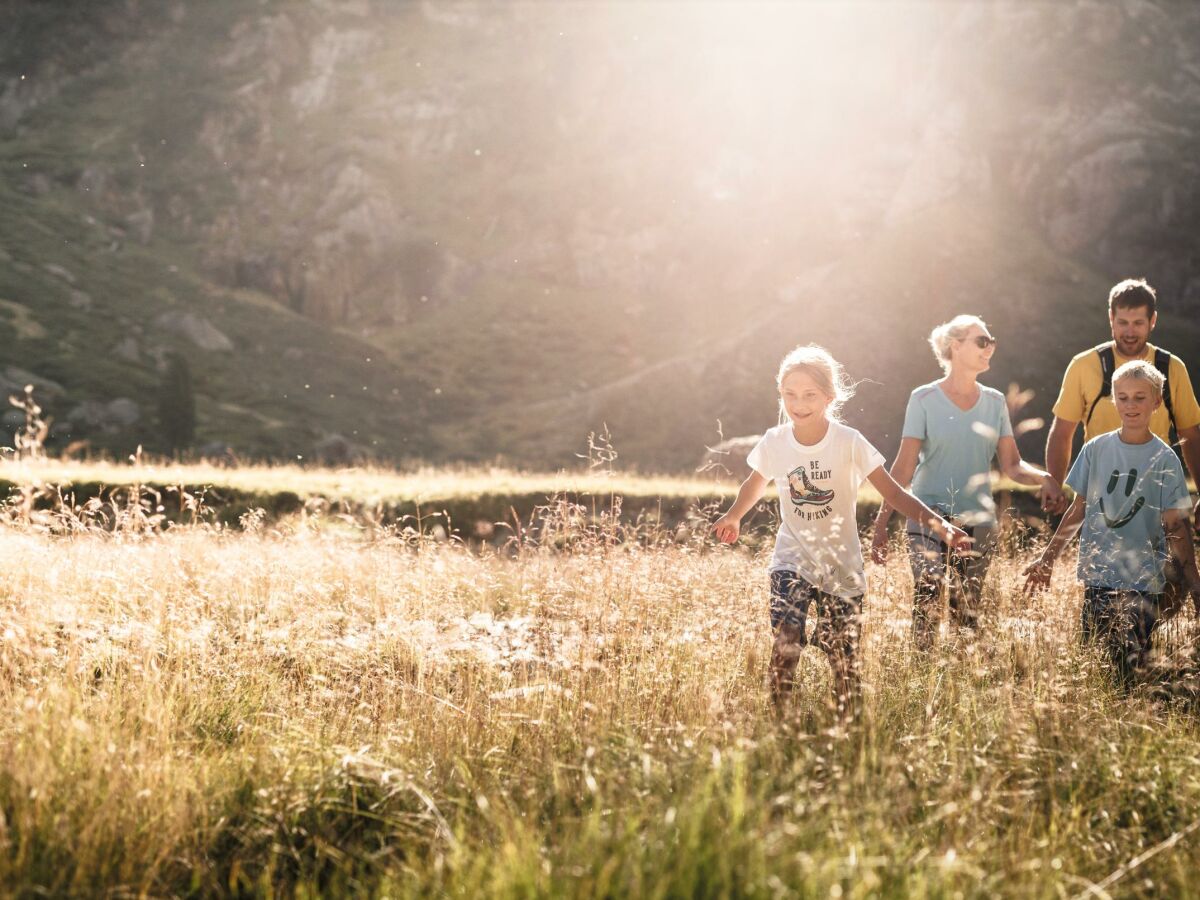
[902, 382, 1013, 526]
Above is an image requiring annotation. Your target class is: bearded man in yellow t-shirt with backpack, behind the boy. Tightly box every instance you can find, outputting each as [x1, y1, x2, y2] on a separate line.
[1046, 278, 1200, 528]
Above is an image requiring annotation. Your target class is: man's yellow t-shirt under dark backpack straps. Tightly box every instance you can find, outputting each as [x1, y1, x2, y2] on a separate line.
[1054, 343, 1200, 440]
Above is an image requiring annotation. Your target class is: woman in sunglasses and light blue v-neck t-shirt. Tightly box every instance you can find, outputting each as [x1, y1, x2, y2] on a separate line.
[871, 316, 1062, 650]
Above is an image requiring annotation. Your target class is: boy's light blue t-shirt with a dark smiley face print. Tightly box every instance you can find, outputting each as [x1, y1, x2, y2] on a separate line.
[1067, 431, 1190, 594]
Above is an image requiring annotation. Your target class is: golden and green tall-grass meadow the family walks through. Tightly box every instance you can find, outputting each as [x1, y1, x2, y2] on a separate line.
[0, 468, 1200, 898]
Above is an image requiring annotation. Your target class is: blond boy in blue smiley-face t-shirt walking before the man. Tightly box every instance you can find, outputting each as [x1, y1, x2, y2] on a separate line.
[1025, 360, 1200, 685]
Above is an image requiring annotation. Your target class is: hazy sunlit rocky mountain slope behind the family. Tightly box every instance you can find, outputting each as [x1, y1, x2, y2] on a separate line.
[0, 0, 1200, 468]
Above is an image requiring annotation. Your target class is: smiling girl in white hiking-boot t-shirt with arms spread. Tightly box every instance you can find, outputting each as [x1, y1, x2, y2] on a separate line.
[713, 344, 970, 718]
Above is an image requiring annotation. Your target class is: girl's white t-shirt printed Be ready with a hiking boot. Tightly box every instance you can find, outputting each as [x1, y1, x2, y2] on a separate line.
[746, 422, 884, 598]
